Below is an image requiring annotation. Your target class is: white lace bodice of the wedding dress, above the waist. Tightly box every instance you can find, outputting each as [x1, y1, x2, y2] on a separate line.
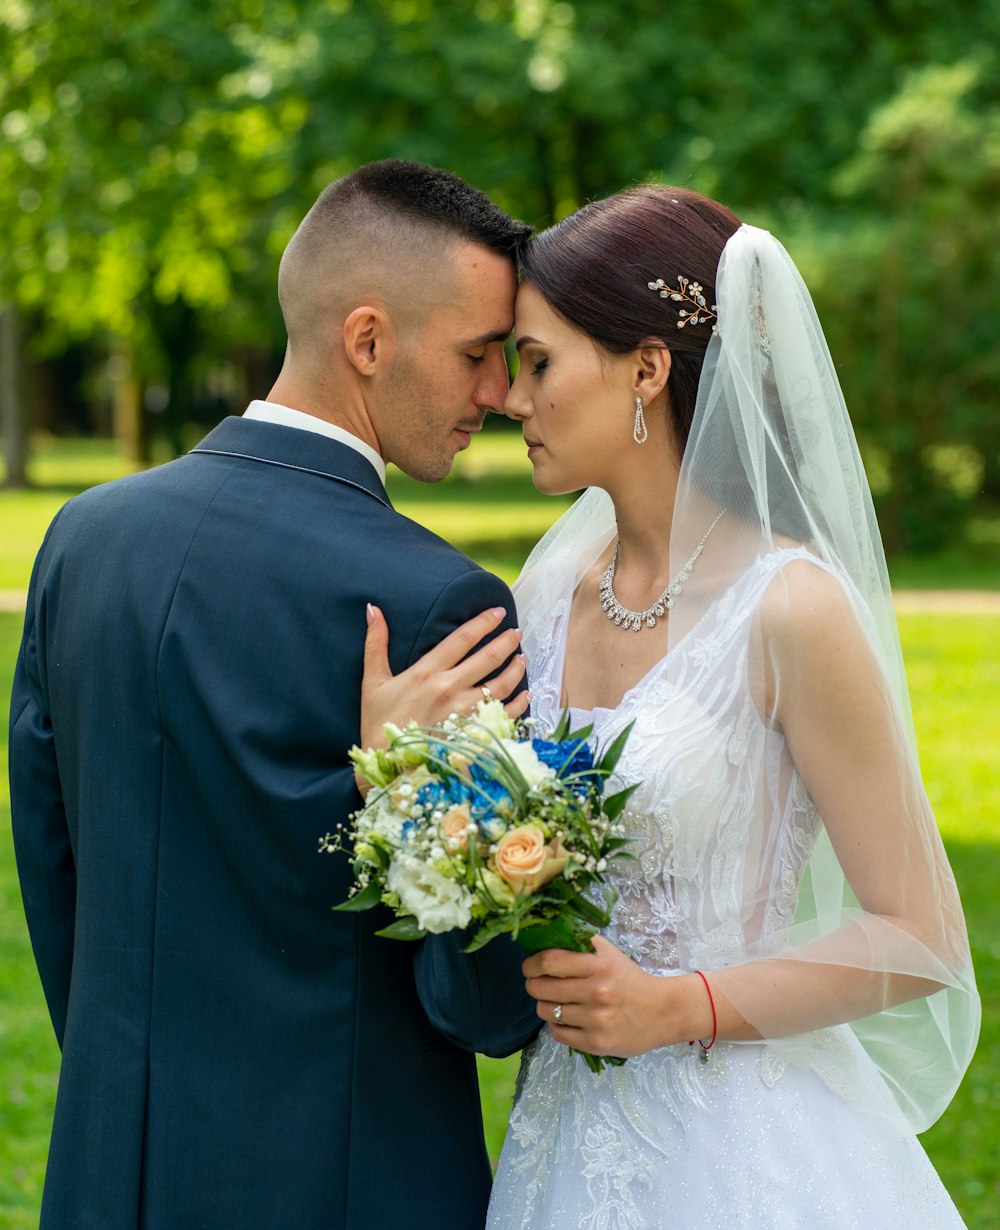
[531, 549, 822, 973]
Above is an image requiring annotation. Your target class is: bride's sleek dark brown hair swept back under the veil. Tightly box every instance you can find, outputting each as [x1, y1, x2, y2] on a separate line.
[522, 185, 740, 450]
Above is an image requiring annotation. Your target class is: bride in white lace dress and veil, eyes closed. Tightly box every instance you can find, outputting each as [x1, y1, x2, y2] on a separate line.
[364, 187, 979, 1230]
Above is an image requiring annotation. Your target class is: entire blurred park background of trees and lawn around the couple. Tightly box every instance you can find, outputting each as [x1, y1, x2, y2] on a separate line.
[0, 0, 1000, 1230]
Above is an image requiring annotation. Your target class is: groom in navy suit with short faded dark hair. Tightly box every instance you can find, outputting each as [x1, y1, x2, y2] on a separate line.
[10, 162, 538, 1230]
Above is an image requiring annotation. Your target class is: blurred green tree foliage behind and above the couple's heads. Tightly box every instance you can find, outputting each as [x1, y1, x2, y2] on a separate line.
[0, 0, 1000, 550]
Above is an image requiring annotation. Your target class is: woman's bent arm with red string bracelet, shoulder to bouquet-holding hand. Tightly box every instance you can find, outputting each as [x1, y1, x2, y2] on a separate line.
[524, 563, 968, 1055]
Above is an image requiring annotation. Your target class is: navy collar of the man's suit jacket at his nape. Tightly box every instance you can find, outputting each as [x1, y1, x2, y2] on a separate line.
[191, 416, 391, 507]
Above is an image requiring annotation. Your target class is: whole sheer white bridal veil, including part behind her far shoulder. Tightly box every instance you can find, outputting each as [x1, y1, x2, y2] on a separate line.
[515, 225, 979, 1132]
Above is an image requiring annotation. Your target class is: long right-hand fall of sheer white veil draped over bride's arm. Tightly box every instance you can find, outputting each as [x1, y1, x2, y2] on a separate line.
[670, 226, 979, 1130]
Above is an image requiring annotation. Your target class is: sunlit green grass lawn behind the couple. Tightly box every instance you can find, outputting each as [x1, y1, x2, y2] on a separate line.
[0, 432, 1000, 1230]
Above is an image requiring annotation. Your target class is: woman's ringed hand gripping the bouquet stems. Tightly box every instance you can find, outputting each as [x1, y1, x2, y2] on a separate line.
[522, 935, 711, 1059]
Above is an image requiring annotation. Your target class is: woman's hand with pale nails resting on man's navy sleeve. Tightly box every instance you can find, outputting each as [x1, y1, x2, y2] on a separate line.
[360, 605, 531, 748]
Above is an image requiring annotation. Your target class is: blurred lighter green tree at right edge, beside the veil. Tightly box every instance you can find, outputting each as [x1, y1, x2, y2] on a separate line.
[811, 57, 1000, 551]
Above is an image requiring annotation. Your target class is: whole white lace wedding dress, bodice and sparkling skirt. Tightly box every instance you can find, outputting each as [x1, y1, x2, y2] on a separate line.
[488, 550, 963, 1230]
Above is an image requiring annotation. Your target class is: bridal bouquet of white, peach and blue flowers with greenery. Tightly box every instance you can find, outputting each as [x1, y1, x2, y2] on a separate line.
[320, 700, 636, 1071]
